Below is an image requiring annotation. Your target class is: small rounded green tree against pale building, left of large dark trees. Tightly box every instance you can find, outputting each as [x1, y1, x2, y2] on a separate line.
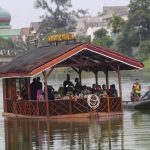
[108, 15, 125, 33]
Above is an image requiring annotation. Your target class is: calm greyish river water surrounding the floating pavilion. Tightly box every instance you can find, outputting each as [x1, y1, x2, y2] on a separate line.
[0, 78, 150, 150]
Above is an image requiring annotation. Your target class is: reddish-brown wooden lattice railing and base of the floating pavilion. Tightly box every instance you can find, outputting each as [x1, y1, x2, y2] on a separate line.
[3, 97, 122, 118]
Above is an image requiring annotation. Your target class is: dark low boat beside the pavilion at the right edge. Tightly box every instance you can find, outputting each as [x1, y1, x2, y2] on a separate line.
[123, 99, 150, 110]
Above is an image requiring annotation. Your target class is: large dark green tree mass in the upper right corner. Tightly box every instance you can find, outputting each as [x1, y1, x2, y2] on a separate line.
[117, 0, 150, 55]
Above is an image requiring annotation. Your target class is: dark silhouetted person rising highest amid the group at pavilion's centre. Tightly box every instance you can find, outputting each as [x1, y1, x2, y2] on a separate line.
[63, 74, 74, 95]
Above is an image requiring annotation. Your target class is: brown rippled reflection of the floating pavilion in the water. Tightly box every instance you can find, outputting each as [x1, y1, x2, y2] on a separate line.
[4, 117, 123, 150]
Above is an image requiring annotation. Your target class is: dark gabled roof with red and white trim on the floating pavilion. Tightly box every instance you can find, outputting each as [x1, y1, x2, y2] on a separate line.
[0, 43, 144, 78]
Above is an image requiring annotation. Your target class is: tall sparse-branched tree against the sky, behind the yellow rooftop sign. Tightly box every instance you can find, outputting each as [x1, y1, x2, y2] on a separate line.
[35, 0, 87, 32]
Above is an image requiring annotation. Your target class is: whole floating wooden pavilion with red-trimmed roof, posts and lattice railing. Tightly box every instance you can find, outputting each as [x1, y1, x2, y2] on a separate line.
[0, 34, 144, 118]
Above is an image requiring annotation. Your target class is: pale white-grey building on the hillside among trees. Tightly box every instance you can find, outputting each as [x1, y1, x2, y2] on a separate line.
[76, 6, 128, 41]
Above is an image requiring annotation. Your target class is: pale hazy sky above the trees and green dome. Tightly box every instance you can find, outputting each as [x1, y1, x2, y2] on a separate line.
[0, 0, 130, 29]
